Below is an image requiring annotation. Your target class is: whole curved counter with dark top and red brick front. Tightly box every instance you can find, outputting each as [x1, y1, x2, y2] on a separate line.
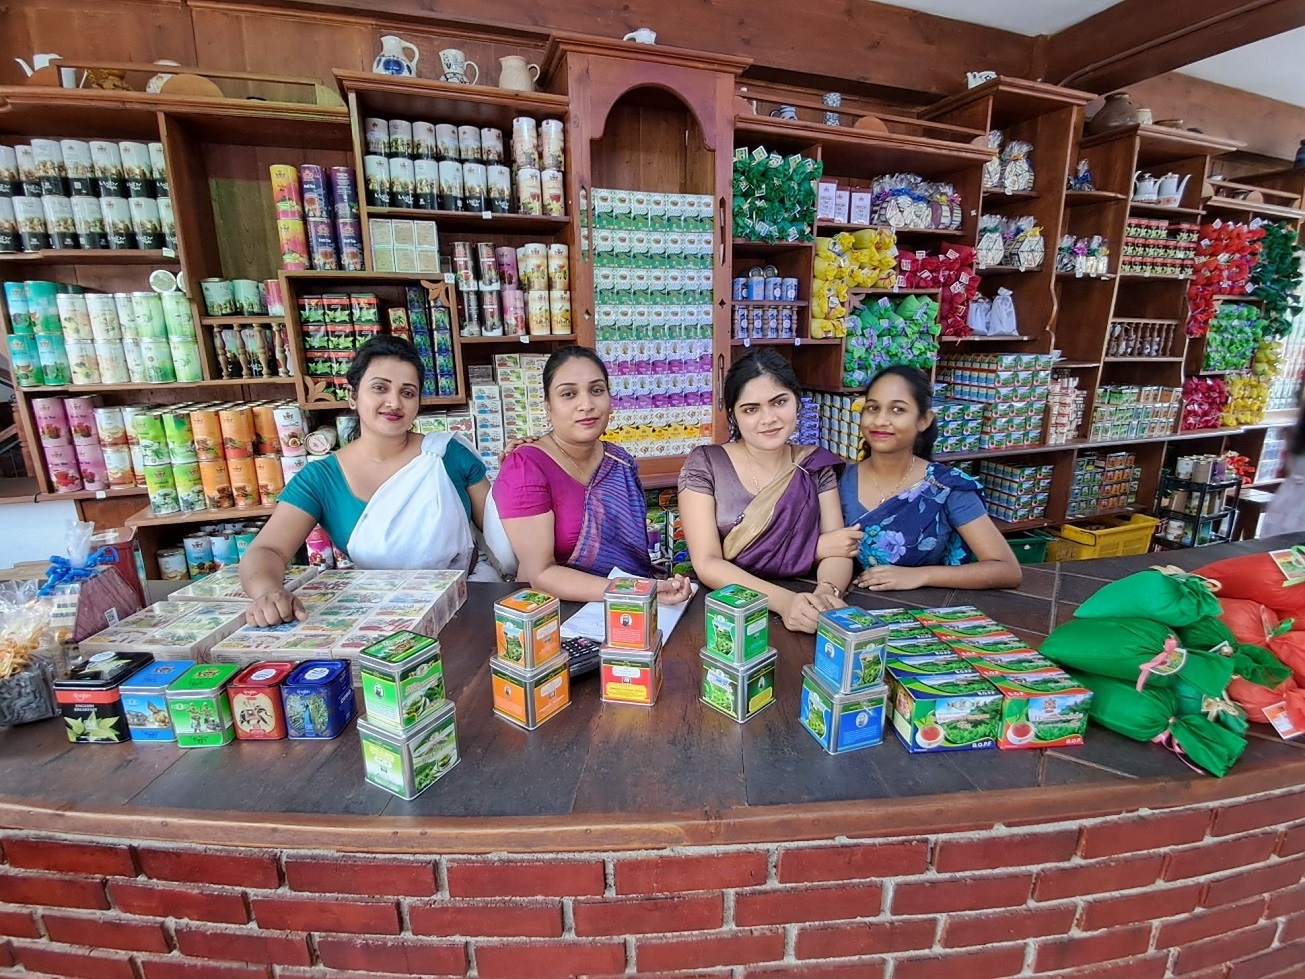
[0, 542, 1305, 979]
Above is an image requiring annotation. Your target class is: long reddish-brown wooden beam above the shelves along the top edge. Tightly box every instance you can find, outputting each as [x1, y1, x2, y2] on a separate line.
[186, 0, 1035, 95]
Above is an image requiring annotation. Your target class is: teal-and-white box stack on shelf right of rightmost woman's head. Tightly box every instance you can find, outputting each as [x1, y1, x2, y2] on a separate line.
[938, 354, 1054, 449]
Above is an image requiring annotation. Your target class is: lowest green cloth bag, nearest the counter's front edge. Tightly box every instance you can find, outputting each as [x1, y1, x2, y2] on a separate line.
[1071, 671, 1246, 777]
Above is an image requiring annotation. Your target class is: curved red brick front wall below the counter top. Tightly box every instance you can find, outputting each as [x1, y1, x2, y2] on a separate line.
[0, 788, 1305, 979]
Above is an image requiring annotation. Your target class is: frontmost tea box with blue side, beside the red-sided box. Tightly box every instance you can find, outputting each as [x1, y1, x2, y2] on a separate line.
[889, 667, 1002, 752]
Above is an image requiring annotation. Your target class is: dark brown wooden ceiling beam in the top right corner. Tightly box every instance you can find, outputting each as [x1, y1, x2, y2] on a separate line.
[1039, 0, 1305, 91]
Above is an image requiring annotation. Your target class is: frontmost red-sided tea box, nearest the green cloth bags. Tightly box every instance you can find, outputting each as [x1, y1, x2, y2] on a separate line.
[987, 666, 1092, 748]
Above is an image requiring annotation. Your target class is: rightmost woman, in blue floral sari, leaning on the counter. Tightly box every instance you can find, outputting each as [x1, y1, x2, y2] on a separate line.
[822, 365, 1022, 591]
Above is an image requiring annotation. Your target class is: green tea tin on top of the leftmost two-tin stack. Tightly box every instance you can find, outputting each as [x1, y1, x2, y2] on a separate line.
[358, 632, 444, 734]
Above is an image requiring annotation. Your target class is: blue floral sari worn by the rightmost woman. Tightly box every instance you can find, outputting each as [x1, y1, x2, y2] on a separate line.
[838, 462, 985, 568]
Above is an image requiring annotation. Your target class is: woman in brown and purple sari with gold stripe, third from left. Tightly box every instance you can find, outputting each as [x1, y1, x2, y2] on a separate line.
[680, 347, 852, 632]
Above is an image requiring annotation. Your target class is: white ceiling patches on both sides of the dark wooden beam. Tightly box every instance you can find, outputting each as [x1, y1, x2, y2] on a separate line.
[877, 0, 1305, 107]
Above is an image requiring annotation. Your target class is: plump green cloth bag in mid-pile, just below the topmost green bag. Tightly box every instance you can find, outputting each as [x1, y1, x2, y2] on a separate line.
[1040, 617, 1232, 697]
